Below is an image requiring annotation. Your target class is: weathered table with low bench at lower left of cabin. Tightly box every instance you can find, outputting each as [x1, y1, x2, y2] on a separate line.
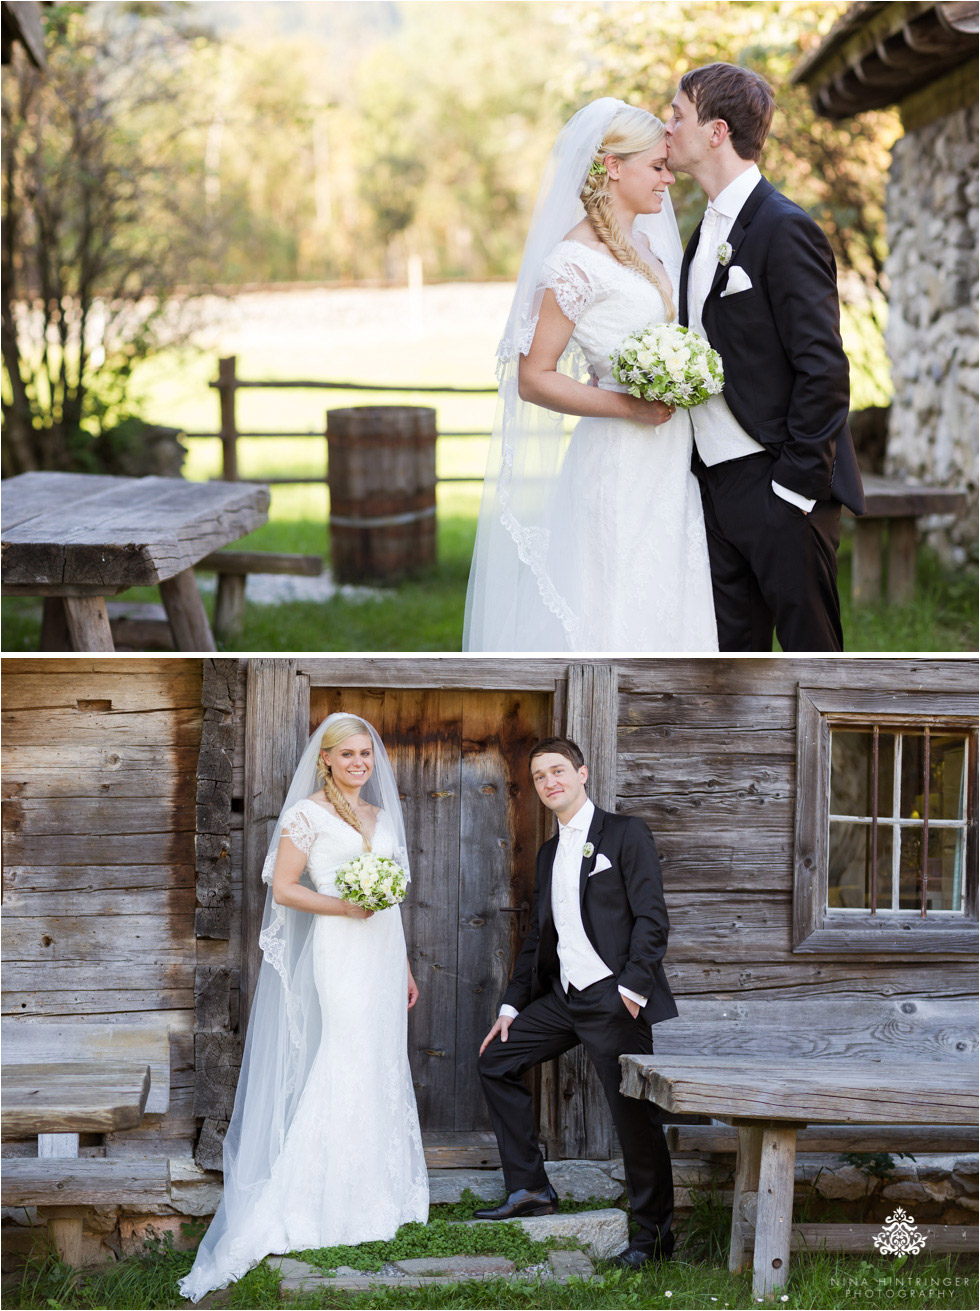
[0, 1061, 160, 1265]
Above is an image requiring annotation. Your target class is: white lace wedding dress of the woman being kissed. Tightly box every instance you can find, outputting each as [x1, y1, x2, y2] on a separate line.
[511, 240, 718, 652]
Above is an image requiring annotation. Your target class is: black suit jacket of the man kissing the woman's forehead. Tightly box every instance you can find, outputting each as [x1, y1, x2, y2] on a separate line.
[679, 178, 865, 514]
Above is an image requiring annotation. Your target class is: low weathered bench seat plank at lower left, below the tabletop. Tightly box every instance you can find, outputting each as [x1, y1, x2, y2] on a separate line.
[1, 1156, 170, 1206]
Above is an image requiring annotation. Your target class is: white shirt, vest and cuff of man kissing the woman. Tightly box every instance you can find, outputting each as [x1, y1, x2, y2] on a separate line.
[688, 164, 816, 513]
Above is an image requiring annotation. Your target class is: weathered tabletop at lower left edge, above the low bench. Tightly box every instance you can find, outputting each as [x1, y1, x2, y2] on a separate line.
[3, 1059, 149, 1137]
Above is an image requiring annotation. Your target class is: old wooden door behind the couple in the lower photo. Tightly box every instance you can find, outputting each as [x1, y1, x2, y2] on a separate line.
[309, 687, 552, 1142]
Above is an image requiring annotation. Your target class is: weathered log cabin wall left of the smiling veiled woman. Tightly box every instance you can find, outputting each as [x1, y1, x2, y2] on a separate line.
[3, 657, 202, 1155]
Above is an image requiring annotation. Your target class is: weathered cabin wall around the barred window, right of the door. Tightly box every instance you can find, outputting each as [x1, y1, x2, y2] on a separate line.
[616, 658, 976, 1022]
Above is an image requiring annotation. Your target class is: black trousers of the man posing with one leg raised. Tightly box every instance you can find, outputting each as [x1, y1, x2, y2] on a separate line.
[478, 977, 673, 1249]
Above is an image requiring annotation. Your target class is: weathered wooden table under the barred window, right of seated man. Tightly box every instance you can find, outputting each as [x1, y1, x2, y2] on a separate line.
[620, 1055, 977, 1297]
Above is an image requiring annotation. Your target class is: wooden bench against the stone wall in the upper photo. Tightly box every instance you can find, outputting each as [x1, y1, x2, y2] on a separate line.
[850, 473, 967, 606]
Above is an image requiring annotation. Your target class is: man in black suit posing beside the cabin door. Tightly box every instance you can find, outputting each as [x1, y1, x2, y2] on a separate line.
[476, 738, 677, 1269]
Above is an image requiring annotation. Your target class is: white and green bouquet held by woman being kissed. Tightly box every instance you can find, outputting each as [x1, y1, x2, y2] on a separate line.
[609, 324, 725, 409]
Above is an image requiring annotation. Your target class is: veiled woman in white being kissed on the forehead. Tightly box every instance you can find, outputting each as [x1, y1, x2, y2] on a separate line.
[462, 98, 718, 652]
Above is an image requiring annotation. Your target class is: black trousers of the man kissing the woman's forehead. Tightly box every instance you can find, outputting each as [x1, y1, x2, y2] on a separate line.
[694, 451, 844, 652]
